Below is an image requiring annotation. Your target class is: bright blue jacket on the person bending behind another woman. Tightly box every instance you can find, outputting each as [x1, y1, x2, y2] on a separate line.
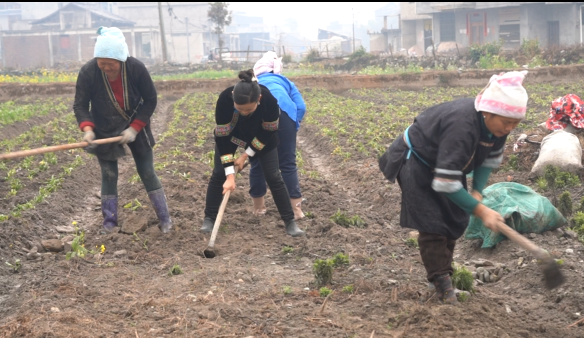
[258, 73, 306, 130]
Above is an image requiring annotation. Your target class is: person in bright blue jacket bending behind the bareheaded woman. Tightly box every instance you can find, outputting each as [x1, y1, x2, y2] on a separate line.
[249, 51, 306, 220]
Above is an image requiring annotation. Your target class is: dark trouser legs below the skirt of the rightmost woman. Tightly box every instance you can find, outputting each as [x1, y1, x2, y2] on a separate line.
[418, 231, 456, 282]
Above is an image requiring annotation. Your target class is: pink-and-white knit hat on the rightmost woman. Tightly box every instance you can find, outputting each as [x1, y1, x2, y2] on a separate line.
[475, 70, 527, 119]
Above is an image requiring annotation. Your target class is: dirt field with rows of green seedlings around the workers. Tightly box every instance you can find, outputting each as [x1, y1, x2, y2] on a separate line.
[0, 72, 584, 337]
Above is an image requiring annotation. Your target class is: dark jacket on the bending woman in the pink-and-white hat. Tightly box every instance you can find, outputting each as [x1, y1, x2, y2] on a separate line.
[380, 99, 507, 182]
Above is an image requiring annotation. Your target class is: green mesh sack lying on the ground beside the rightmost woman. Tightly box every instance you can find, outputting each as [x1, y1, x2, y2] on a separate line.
[465, 182, 566, 248]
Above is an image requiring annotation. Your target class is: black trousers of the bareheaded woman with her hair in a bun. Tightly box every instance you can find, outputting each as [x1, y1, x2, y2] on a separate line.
[205, 147, 294, 222]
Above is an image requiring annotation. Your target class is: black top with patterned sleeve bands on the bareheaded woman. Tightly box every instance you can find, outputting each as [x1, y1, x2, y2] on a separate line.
[214, 85, 280, 167]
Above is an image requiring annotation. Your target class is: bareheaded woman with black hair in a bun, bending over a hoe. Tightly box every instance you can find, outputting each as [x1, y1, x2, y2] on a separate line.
[201, 69, 305, 237]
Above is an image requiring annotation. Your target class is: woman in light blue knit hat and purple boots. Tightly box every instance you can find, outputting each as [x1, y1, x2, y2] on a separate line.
[73, 27, 172, 233]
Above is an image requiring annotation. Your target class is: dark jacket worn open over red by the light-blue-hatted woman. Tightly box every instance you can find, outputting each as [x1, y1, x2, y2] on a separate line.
[73, 56, 157, 160]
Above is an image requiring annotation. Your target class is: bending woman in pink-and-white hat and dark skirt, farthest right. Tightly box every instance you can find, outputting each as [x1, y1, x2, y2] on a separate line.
[379, 72, 527, 303]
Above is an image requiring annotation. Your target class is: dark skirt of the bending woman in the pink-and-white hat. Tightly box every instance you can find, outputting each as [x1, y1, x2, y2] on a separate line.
[379, 136, 470, 239]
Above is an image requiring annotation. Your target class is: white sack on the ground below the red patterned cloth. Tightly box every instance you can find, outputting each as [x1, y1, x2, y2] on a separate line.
[531, 130, 582, 176]
